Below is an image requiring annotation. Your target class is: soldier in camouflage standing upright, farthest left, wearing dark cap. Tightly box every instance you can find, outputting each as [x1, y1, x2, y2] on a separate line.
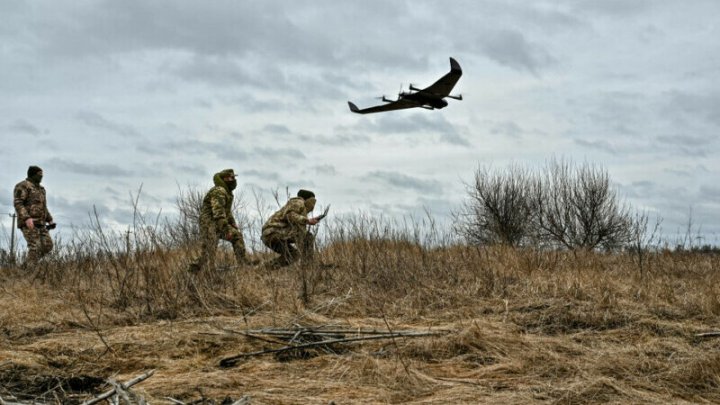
[13, 166, 55, 268]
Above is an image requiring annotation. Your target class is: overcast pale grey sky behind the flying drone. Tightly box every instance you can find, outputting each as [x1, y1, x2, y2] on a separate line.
[0, 0, 720, 243]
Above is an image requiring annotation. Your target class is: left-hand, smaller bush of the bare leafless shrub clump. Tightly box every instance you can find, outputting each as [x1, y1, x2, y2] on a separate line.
[453, 166, 533, 246]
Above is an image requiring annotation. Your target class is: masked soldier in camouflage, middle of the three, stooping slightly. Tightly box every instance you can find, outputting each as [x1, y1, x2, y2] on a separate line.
[190, 169, 249, 272]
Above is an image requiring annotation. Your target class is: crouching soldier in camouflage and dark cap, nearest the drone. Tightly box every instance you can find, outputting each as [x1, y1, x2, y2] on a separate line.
[261, 190, 319, 267]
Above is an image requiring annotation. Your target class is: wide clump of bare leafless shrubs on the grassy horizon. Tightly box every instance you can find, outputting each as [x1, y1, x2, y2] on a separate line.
[454, 160, 638, 250]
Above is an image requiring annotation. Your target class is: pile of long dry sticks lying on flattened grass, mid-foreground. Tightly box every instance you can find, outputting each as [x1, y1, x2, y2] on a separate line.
[220, 325, 450, 367]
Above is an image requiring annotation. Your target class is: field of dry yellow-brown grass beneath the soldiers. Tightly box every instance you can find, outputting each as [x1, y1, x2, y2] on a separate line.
[0, 229, 720, 404]
